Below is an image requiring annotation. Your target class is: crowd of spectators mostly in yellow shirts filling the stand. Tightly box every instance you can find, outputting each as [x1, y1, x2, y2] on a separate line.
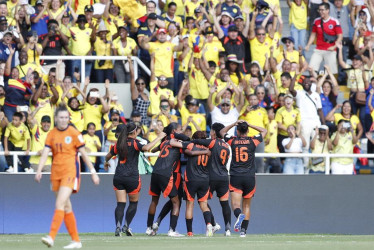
[0, 0, 374, 174]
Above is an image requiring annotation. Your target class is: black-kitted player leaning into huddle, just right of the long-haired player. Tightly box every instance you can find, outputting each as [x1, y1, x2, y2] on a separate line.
[146, 123, 183, 237]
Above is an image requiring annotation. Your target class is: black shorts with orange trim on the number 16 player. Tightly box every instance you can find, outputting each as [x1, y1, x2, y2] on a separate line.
[230, 176, 256, 198]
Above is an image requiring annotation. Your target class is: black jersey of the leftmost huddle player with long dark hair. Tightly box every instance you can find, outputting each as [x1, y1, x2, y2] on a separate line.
[110, 138, 143, 180]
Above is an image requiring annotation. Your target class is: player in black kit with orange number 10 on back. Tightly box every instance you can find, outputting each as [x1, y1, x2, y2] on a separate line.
[171, 131, 213, 236]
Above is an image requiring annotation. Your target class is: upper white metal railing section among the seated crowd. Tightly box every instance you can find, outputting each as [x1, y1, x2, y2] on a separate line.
[40, 56, 151, 79]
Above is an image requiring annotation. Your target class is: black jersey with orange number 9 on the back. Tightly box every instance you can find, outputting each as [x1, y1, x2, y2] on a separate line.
[192, 139, 230, 181]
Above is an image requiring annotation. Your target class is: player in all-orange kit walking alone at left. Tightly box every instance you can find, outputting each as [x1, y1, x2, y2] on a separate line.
[35, 105, 100, 249]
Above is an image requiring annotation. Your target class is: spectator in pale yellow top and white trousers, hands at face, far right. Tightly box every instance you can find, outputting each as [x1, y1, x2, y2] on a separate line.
[331, 119, 359, 174]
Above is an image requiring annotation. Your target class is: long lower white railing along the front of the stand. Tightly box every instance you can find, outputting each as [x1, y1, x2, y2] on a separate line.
[0, 151, 374, 175]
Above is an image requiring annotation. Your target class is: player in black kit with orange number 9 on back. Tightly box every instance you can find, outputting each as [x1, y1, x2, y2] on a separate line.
[192, 123, 231, 236]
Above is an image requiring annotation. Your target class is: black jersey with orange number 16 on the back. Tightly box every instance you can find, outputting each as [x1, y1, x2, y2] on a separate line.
[224, 134, 263, 176]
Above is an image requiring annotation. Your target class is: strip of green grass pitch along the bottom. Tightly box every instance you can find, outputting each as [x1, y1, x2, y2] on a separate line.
[0, 233, 374, 250]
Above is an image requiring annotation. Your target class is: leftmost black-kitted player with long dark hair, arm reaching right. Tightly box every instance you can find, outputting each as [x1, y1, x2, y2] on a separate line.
[105, 123, 166, 236]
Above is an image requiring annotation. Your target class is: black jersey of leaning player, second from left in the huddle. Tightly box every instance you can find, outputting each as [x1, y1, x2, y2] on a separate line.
[152, 139, 182, 178]
